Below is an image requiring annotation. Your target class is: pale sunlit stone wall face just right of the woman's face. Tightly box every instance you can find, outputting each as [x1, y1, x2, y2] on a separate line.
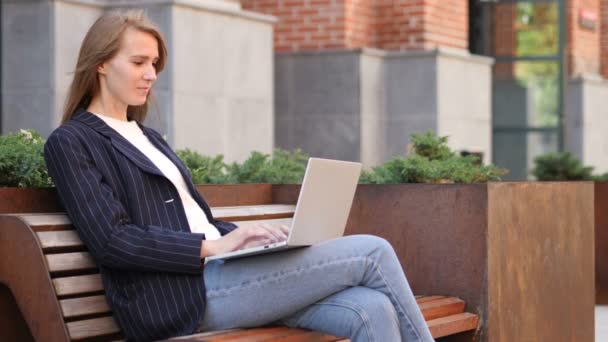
[169, 6, 274, 160]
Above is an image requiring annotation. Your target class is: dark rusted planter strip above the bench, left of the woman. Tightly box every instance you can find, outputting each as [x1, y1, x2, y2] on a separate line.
[0, 188, 64, 214]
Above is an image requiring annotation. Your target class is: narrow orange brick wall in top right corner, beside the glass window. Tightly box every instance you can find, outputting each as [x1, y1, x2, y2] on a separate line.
[566, 0, 601, 76]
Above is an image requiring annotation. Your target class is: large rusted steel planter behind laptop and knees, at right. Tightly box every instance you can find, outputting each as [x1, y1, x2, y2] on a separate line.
[273, 182, 595, 341]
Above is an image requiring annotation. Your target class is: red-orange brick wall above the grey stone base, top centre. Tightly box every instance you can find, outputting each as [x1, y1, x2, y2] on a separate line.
[241, 0, 468, 51]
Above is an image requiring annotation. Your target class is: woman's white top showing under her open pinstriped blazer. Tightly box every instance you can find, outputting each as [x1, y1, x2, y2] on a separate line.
[93, 113, 221, 240]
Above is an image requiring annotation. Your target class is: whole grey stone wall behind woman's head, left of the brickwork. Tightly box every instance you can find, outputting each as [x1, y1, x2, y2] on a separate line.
[1, 0, 274, 161]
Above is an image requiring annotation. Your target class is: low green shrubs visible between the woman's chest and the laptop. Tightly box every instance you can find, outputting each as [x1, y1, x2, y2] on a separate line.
[177, 149, 308, 184]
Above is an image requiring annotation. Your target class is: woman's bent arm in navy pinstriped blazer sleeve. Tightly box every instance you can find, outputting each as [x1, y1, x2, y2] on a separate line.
[44, 129, 204, 274]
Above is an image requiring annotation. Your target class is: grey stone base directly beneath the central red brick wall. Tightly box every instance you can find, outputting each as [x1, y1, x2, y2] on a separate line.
[275, 49, 492, 166]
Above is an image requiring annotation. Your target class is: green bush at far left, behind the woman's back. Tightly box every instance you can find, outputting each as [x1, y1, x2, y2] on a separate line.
[0, 129, 53, 188]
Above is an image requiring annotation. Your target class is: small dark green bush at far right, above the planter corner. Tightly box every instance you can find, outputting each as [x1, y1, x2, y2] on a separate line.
[532, 152, 592, 181]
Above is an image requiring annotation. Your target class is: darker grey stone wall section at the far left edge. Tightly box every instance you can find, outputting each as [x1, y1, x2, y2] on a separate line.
[0, 1, 56, 135]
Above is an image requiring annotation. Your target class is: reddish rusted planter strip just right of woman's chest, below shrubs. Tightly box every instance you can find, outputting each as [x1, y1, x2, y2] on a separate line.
[196, 184, 272, 207]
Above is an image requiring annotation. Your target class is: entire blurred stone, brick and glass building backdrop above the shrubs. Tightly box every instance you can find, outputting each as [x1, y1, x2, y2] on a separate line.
[0, 0, 608, 180]
